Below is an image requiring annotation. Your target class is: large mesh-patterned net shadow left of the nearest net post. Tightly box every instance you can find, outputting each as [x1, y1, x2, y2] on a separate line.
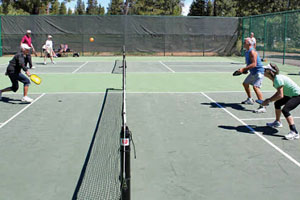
[73, 89, 122, 200]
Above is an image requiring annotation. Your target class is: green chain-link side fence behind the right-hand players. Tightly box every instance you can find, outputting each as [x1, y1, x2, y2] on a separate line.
[242, 10, 300, 66]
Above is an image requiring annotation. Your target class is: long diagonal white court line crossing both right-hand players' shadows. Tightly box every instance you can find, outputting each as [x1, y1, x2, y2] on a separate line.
[201, 92, 300, 167]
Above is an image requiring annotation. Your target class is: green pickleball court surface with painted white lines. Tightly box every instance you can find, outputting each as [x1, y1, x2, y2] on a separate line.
[0, 56, 300, 200]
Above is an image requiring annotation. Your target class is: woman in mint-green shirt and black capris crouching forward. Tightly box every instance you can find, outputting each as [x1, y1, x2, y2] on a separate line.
[262, 63, 300, 140]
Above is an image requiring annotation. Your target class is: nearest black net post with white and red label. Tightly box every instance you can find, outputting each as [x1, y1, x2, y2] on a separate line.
[120, 126, 130, 200]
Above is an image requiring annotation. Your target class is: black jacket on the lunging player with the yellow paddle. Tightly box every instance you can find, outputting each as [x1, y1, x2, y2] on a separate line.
[6, 52, 28, 74]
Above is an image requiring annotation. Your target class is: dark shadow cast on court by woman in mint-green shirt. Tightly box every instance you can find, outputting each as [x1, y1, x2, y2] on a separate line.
[218, 125, 284, 138]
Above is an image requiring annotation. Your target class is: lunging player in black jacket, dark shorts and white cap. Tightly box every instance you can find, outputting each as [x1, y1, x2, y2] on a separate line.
[0, 44, 33, 103]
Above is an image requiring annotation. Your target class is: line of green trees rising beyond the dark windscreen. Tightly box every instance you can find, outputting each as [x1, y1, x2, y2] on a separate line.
[0, 0, 300, 17]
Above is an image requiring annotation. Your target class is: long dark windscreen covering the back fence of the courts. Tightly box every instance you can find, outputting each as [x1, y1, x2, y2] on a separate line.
[1, 16, 240, 56]
